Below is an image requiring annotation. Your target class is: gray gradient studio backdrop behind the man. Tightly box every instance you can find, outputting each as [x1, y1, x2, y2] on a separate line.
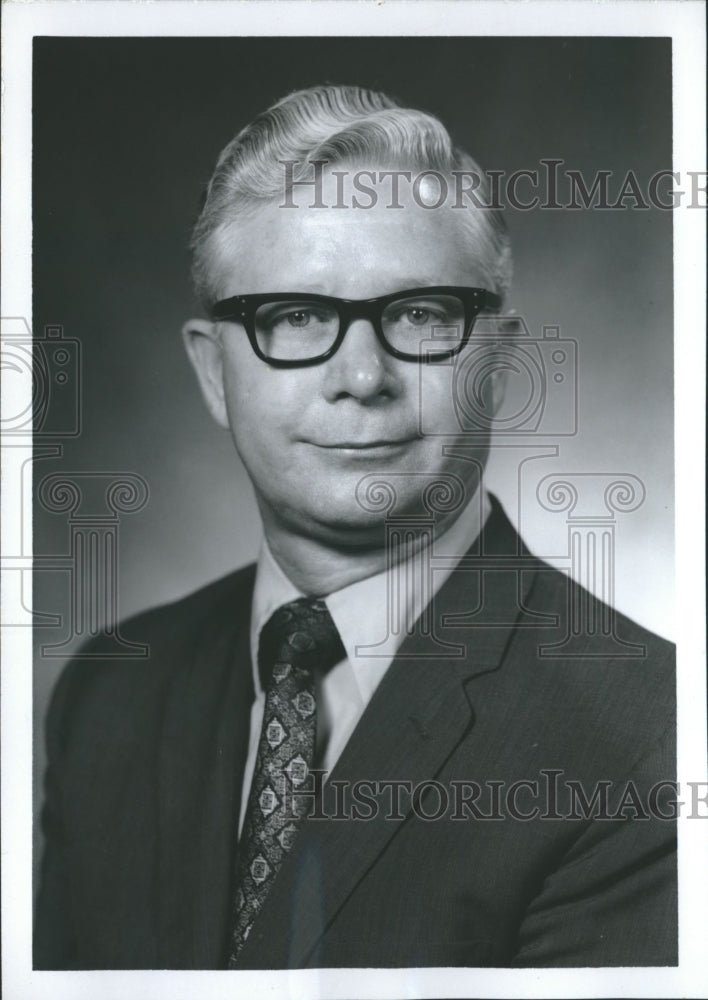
[33, 38, 673, 880]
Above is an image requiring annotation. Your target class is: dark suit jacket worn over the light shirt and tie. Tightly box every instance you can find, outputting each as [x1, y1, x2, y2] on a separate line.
[35, 503, 677, 969]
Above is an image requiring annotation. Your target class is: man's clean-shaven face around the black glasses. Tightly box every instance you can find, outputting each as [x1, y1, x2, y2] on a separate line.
[187, 170, 504, 548]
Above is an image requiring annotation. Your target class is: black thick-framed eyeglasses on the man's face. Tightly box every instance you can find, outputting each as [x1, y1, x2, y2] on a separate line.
[211, 285, 501, 368]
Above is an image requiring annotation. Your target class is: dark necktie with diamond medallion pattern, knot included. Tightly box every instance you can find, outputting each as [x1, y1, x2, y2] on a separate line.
[228, 598, 346, 969]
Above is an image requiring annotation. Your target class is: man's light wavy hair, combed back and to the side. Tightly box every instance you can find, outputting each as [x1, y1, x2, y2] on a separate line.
[191, 86, 512, 309]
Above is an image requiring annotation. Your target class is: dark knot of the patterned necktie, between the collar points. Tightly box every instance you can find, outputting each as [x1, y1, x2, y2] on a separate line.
[258, 597, 346, 689]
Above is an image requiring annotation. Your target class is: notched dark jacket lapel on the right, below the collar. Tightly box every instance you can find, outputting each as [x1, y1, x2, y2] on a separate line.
[239, 505, 533, 969]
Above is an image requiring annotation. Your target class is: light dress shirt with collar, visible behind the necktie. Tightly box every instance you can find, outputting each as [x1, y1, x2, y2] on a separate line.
[239, 492, 491, 835]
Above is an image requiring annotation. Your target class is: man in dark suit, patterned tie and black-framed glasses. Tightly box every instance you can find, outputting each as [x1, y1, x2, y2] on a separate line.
[35, 87, 677, 969]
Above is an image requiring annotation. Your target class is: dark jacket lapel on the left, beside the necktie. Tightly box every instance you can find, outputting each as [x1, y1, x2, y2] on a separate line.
[157, 572, 253, 969]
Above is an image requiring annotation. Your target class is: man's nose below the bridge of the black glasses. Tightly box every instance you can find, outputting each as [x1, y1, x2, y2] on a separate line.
[326, 319, 397, 401]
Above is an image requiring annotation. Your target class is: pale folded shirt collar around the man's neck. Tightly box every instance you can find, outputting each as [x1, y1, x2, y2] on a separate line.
[251, 490, 491, 700]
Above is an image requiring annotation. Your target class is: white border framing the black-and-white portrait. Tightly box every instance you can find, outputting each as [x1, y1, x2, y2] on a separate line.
[0, 0, 708, 1000]
